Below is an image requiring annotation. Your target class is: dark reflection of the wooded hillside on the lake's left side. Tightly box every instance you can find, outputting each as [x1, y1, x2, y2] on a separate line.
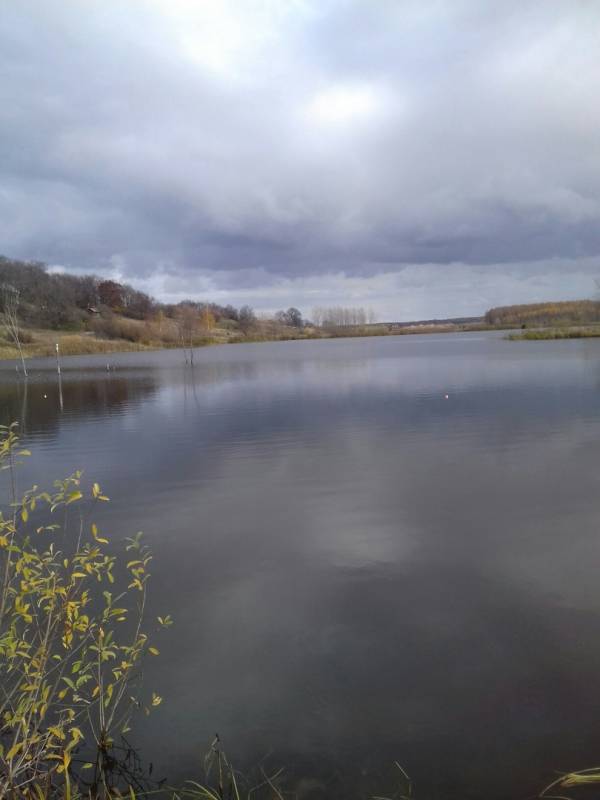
[0, 373, 159, 433]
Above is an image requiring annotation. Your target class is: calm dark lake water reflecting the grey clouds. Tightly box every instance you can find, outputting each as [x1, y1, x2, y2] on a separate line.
[0, 334, 600, 800]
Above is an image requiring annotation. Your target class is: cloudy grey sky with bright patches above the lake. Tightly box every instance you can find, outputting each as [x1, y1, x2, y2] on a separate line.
[0, 0, 600, 320]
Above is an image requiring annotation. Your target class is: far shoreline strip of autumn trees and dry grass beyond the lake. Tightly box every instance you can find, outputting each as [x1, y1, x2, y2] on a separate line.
[5, 256, 600, 360]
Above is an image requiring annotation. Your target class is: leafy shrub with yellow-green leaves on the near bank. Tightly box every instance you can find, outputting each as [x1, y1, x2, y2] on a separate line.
[0, 425, 170, 800]
